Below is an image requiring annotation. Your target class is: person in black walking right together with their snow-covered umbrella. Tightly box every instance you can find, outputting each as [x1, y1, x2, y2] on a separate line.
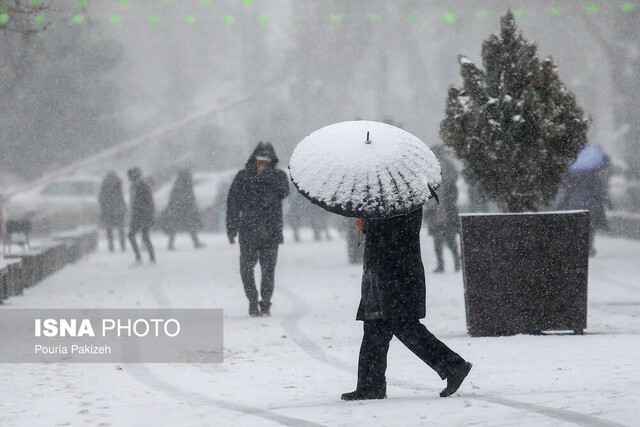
[289, 121, 471, 400]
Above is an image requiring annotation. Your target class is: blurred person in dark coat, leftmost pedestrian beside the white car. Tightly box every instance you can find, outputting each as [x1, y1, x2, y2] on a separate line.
[98, 172, 127, 252]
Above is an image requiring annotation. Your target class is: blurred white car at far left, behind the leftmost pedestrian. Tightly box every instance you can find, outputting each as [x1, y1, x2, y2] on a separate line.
[5, 176, 102, 231]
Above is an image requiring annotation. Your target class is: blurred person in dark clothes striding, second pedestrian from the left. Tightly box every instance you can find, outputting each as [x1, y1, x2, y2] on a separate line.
[127, 167, 156, 264]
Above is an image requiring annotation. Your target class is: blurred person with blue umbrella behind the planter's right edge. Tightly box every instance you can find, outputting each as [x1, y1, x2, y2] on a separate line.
[558, 145, 611, 256]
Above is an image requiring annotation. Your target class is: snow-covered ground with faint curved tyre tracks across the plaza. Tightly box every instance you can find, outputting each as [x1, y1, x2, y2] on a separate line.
[0, 232, 640, 426]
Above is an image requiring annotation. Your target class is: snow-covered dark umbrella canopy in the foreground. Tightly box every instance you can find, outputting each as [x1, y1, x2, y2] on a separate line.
[289, 120, 440, 219]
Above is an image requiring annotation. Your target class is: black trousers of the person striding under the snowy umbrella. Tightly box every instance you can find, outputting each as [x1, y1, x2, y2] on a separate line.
[357, 319, 464, 390]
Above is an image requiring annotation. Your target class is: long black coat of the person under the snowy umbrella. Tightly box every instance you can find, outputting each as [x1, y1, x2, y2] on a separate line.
[356, 209, 426, 320]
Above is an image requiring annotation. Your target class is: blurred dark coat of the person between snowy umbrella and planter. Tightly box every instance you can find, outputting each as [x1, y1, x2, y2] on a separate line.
[425, 157, 460, 239]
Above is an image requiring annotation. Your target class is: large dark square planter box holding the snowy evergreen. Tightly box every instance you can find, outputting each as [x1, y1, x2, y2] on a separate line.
[460, 211, 589, 336]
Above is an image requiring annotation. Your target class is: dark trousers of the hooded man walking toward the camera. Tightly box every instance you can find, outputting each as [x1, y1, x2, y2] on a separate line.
[240, 241, 278, 304]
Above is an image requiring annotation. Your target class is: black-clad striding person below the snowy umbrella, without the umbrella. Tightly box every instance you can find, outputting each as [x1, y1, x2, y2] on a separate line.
[342, 209, 471, 400]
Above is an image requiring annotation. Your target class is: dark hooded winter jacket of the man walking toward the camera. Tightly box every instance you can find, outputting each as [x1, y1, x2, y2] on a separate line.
[227, 143, 289, 244]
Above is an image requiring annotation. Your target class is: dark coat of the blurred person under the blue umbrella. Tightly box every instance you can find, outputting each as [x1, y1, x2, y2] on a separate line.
[558, 169, 609, 230]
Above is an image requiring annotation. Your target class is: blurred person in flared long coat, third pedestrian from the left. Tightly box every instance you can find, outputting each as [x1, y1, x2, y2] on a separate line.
[160, 169, 204, 250]
